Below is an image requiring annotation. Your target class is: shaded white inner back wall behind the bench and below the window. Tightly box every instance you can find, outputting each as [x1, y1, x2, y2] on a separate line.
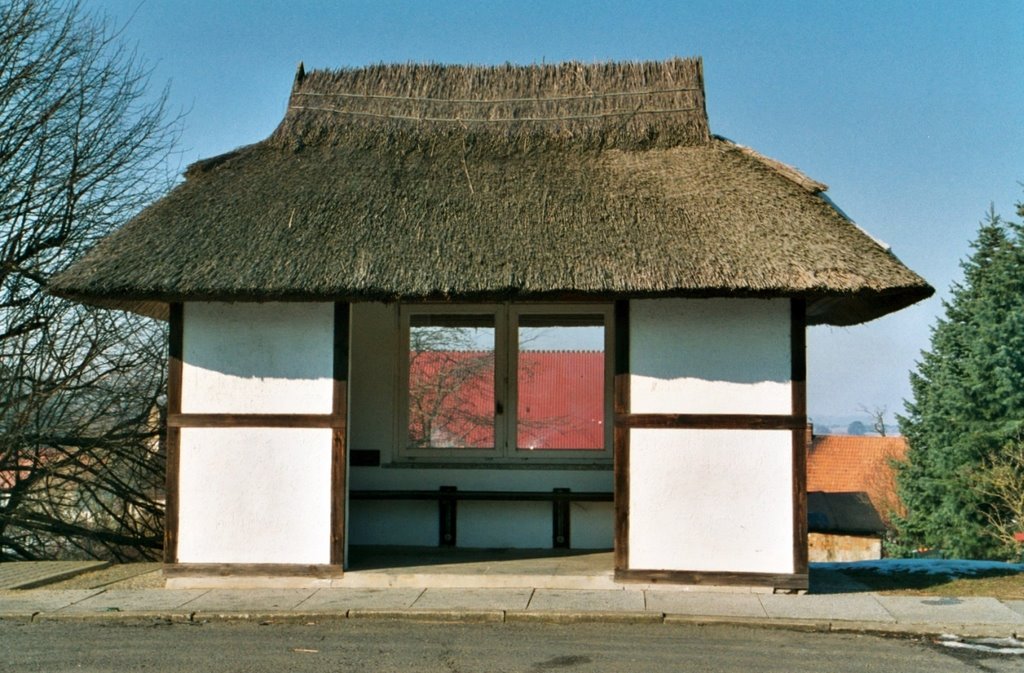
[348, 303, 613, 549]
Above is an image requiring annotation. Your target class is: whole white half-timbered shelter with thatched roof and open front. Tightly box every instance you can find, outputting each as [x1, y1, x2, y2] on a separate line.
[50, 59, 933, 589]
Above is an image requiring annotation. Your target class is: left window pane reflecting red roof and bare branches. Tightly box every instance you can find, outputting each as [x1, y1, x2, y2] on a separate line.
[408, 313, 495, 449]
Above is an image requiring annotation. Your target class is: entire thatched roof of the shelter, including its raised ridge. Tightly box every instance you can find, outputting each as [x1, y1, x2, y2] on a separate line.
[50, 59, 932, 324]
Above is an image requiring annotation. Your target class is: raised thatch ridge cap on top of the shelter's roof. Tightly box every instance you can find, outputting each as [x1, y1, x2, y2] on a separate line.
[270, 58, 710, 151]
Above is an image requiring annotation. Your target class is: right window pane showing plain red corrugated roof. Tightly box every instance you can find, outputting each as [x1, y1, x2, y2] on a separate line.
[516, 314, 604, 451]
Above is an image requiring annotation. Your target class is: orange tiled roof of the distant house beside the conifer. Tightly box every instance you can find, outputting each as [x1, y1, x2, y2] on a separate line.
[807, 434, 907, 519]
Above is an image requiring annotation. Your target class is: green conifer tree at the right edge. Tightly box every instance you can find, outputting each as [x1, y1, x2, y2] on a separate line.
[895, 199, 1024, 558]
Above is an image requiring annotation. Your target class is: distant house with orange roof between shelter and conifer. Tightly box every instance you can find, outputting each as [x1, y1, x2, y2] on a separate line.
[807, 434, 907, 561]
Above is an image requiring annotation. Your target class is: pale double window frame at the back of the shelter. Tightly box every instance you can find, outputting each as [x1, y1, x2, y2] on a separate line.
[393, 302, 614, 466]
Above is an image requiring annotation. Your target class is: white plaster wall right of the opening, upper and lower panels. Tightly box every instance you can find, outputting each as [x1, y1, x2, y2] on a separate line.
[629, 299, 795, 573]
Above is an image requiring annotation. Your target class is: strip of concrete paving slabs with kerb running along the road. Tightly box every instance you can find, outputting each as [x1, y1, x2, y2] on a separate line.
[0, 587, 1024, 636]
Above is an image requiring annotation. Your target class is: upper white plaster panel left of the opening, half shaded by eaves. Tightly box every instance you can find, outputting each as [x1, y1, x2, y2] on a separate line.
[181, 302, 334, 414]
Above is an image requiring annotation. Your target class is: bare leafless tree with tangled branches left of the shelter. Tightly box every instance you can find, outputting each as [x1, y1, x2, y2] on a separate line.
[0, 0, 179, 559]
